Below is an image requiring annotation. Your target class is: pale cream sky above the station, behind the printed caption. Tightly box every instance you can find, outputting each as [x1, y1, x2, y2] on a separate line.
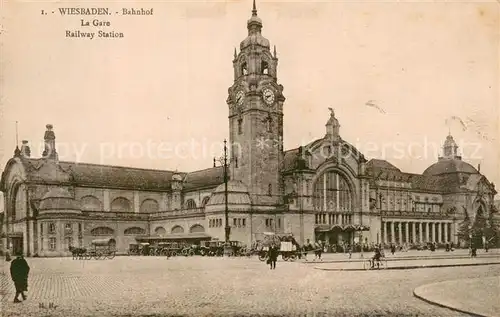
[0, 0, 500, 196]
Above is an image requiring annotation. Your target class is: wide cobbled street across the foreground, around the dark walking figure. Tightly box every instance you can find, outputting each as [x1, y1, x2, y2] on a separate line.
[0, 257, 500, 317]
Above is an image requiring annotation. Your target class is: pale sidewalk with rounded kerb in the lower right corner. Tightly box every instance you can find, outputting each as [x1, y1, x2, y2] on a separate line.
[413, 276, 500, 316]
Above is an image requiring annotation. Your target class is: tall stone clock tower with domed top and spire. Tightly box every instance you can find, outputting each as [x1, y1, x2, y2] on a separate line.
[227, 0, 285, 205]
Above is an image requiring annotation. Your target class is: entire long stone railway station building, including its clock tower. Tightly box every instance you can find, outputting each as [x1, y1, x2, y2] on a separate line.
[0, 2, 497, 256]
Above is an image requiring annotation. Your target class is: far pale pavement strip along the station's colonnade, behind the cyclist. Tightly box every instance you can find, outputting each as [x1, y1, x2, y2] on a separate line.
[302, 249, 500, 264]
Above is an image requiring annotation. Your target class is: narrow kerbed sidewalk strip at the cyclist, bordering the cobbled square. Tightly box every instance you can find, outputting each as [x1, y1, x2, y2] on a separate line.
[315, 258, 500, 271]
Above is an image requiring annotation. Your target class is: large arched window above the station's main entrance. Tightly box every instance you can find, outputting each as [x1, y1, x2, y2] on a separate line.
[313, 171, 353, 212]
